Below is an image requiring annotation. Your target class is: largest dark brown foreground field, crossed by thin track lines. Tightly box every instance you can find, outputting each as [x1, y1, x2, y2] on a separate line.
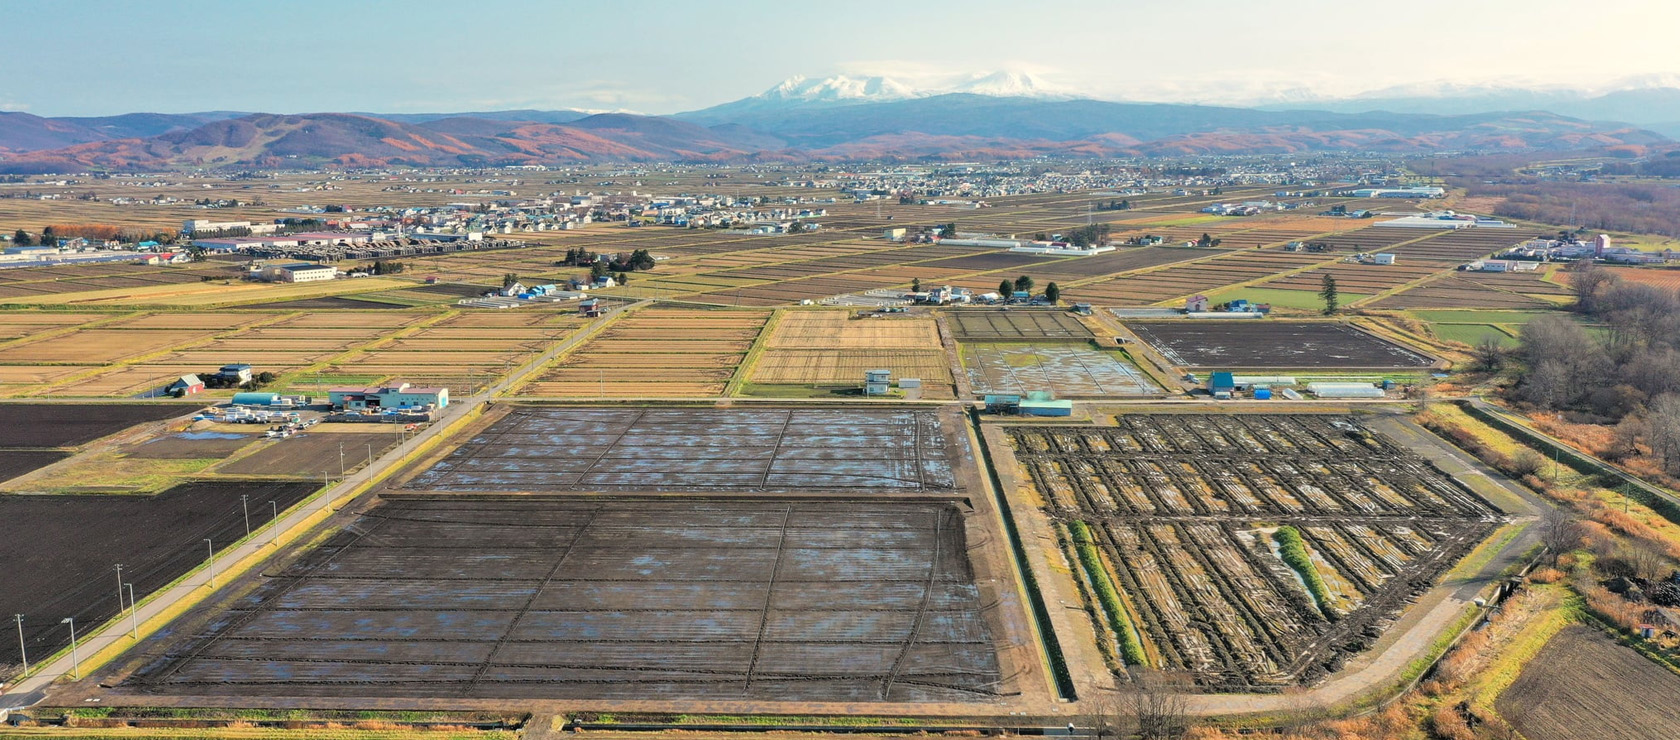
[124, 496, 1001, 701]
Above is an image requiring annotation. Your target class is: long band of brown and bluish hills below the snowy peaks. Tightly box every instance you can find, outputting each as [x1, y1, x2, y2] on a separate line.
[0, 101, 1672, 173]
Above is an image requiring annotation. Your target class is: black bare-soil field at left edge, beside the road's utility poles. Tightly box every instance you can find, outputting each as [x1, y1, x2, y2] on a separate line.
[0, 481, 316, 676]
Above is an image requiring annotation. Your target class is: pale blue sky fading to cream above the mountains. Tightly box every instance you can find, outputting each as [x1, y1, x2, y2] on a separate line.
[0, 0, 1680, 116]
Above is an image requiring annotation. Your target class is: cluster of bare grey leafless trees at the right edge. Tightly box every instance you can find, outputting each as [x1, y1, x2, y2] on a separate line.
[1505, 266, 1680, 474]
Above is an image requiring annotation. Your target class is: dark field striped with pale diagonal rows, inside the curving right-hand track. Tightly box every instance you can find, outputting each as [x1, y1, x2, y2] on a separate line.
[1006, 414, 1500, 691]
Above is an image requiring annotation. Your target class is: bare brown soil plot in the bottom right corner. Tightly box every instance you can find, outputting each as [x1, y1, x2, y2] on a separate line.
[1494, 627, 1680, 740]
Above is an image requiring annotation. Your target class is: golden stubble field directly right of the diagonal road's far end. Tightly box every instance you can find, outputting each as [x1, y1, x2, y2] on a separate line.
[519, 308, 771, 397]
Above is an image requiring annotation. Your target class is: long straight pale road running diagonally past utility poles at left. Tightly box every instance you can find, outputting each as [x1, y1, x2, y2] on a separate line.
[0, 304, 640, 710]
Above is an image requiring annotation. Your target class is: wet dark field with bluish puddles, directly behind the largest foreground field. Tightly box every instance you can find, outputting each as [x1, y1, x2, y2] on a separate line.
[405, 407, 973, 493]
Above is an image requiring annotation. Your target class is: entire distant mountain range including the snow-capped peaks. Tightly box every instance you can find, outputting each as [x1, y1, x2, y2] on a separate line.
[0, 72, 1680, 173]
